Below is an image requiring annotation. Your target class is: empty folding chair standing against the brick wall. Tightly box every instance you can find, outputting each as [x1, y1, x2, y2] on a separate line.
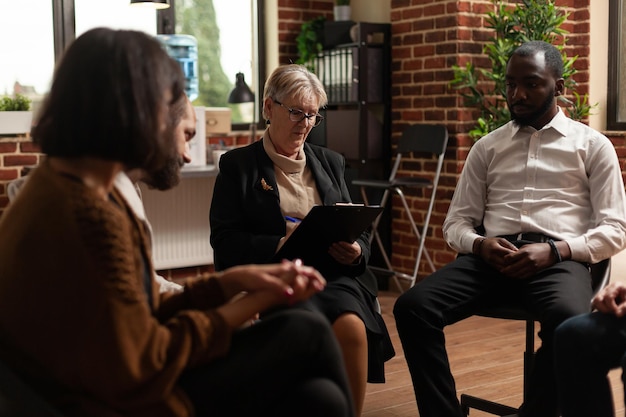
[352, 124, 448, 290]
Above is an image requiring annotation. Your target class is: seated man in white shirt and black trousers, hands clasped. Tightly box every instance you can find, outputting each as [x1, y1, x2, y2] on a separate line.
[394, 42, 626, 417]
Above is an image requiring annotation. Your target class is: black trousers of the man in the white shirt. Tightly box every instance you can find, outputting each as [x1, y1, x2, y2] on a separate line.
[394, 255, 592, 417]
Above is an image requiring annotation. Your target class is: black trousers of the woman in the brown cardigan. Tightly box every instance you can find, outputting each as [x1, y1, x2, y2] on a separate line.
[179, 309, 354, 417]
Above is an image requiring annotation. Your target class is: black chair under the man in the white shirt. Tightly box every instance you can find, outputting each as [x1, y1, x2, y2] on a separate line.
[461, 258, 611, 416]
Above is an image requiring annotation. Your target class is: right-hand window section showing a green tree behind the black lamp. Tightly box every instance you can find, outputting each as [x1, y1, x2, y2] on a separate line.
[157, 0, 265, 130]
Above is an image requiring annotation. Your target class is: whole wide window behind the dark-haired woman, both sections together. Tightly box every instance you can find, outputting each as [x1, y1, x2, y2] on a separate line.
[0, 0, 265, 129]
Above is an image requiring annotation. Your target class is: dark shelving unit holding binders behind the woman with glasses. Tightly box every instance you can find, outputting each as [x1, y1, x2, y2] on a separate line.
[308, 22, 391, 272]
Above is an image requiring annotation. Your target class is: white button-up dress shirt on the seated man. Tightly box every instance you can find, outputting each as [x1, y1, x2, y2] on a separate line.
[443, 109, 626, 263]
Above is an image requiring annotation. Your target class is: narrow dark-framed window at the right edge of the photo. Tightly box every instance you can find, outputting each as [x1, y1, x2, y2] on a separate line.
[607, 0, 626, 130]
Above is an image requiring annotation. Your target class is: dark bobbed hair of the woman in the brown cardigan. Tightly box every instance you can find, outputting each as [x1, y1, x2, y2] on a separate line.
[32, 28, 184, 169]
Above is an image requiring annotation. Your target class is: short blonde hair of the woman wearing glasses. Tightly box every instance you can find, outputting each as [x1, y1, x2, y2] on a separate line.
[263, 64, 328, 119]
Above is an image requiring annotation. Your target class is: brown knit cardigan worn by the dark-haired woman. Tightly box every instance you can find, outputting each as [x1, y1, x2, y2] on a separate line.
[0, 162, 231, 417]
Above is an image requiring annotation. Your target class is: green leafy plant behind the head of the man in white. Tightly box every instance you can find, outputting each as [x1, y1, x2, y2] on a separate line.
[450, 0, 594, 140]
